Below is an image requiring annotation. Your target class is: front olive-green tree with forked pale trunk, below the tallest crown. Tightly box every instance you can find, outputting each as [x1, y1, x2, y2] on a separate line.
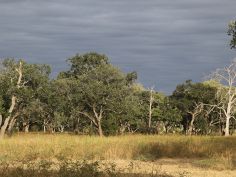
[77, 65, 136, 136]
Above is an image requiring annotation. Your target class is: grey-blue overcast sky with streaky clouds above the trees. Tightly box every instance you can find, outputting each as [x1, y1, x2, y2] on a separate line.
[0, 0, 236, 94]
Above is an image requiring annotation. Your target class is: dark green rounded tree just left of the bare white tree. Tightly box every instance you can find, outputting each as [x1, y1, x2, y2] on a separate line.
[171, 80, 216, 135]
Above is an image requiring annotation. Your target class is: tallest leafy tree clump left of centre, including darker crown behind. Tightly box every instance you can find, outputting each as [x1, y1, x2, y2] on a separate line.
[58, 53, 137, 136]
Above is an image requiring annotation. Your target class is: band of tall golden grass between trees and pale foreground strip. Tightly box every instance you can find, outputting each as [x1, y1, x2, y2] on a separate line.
[0, 134, 236, 176]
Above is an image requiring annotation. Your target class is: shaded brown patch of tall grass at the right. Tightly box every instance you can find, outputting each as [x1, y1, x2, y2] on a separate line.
[135, 138, 236, 170]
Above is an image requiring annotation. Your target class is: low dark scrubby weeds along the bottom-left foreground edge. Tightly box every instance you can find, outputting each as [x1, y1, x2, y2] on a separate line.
[0, 161, 172, 177]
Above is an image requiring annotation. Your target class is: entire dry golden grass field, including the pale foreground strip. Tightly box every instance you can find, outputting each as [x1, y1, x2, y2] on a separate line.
[0, 133, 236, 177]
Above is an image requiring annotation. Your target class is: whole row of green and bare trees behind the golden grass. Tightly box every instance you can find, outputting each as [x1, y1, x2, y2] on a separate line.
[0, 21, 236, 138]
